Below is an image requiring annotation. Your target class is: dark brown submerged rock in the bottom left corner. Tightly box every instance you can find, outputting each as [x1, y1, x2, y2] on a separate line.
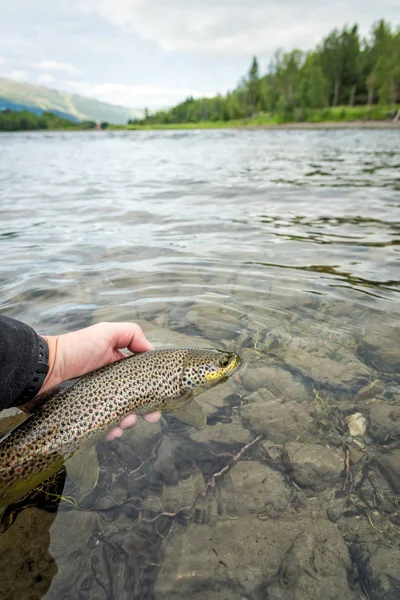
[0, 508, 57, 600]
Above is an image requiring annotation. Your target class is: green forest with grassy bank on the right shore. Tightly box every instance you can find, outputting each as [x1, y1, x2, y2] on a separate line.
[128, 20, 400, 126]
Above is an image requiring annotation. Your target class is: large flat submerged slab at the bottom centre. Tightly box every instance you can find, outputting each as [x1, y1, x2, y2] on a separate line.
[155, 516, 304, 600]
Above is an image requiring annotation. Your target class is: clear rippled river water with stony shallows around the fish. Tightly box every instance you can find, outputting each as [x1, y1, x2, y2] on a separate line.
[0, 130, 400, 599]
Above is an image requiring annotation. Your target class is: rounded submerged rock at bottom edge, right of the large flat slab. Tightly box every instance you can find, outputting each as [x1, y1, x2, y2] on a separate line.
[268, 520, 359, 600]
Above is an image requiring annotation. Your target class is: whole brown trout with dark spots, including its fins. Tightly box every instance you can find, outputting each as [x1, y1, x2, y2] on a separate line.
[0, 347, 242, 509]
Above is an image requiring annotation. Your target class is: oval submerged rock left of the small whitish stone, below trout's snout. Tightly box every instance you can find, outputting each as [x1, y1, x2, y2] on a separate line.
[240, 390, 313, 444]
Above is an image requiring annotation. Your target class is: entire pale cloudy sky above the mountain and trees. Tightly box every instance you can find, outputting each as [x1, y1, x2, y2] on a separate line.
[0, 0, 400, 109]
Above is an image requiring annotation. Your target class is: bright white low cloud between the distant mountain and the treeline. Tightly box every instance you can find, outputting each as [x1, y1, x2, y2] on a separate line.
[68, 81, 215, 108]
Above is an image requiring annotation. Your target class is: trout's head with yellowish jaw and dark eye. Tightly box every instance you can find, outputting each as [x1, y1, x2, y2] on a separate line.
[181, 348, 242, 392]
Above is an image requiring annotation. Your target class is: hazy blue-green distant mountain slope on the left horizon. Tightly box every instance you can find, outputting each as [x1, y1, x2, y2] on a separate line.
[0, 78, 143, 125]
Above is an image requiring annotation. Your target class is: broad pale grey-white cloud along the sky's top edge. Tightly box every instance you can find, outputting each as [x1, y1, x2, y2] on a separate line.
[77, 0, 398, 56]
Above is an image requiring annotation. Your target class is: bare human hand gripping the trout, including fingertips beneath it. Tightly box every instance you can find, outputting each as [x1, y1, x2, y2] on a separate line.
[40, 323, 161, 440]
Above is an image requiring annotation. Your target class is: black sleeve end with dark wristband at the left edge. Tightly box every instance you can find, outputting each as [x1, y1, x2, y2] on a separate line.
[0, 315, 48, 410]
